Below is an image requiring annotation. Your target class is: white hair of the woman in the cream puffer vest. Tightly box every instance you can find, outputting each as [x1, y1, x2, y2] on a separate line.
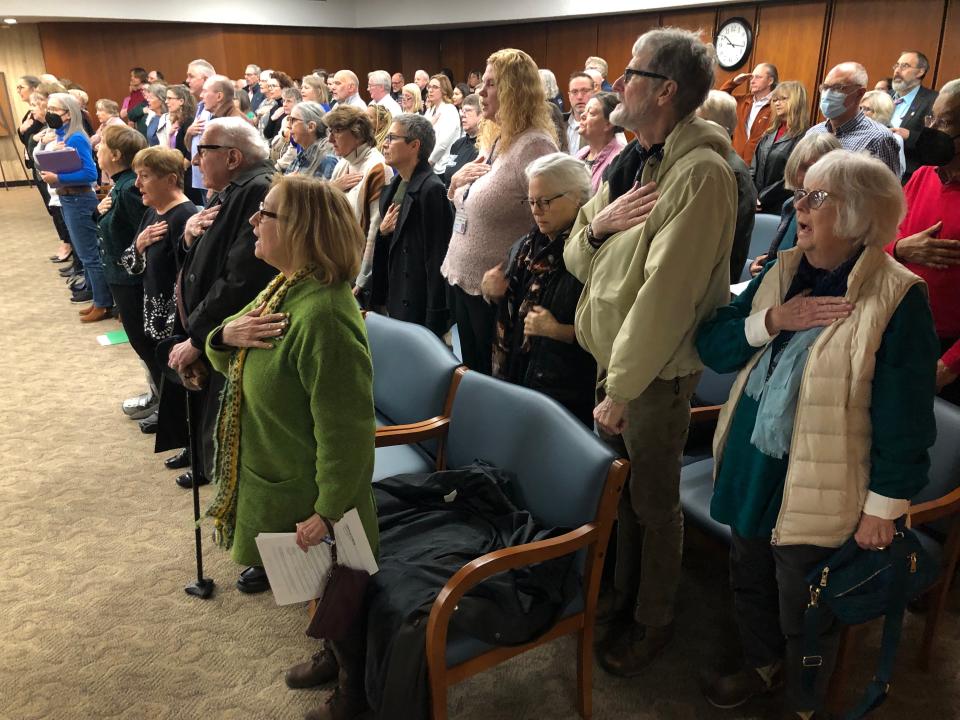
[803, 150, 906, 247]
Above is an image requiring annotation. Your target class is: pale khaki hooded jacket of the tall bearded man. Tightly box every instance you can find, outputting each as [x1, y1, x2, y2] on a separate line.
[563, 116, 737, 403]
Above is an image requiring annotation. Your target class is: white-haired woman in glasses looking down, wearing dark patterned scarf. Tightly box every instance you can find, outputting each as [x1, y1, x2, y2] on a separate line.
[481, 153, 597, 427]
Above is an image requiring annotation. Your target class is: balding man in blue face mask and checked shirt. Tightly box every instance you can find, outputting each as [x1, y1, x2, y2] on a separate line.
[807, 62, 904, 178]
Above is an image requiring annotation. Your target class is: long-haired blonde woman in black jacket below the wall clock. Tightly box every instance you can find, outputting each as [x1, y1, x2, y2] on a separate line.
[750, 80, 809, 214]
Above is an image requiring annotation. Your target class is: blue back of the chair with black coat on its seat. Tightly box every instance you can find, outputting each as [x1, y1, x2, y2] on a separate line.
[446, 372, 617, 528]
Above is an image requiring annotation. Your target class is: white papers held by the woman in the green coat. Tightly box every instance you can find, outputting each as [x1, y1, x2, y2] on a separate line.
[256, 509, 378, 605]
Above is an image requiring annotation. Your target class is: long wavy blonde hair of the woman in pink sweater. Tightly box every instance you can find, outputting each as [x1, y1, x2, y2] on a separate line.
[478, 48, 557, 153]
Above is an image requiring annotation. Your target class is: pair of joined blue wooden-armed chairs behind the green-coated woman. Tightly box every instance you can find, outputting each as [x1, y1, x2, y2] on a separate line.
[366, 313, 629, 720]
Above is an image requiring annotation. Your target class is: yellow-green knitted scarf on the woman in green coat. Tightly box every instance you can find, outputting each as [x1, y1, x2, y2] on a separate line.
[205, 265, 316, 550]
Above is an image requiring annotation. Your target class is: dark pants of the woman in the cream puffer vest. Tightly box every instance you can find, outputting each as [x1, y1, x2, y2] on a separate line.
[730, 533, 840, 712]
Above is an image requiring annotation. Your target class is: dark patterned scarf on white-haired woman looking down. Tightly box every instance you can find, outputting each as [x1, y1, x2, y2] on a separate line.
[493, 229, 570, 383]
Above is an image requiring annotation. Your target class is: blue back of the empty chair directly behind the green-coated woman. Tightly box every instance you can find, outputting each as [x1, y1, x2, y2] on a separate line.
[366, 312, 460, 425]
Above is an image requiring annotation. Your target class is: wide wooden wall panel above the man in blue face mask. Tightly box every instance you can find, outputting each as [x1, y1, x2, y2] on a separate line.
[824, 0, 945, 87]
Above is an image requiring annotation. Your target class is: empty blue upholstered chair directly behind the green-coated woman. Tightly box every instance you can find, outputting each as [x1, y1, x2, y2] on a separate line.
[366, 313, 460, 482]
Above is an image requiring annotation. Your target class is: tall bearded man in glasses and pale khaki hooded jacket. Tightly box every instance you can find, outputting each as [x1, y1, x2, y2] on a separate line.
[563, 28, 737, 677]
